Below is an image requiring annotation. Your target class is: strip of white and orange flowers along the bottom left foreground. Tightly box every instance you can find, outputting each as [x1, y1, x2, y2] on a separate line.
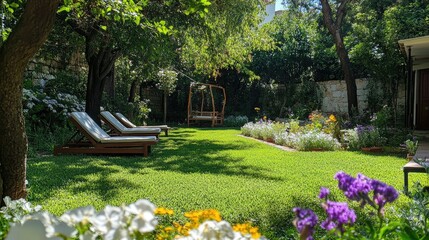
[0, 198, 264, 240]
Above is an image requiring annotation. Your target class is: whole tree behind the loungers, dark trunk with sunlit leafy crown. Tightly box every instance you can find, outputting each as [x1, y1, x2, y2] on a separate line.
[60, 0, 210, 123]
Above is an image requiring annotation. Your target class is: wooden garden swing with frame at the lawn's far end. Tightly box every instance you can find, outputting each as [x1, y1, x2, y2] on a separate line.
[188, 83, 226, 127]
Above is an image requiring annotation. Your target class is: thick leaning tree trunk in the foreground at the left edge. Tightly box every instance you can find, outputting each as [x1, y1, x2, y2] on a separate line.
[0, 0, 59, 202]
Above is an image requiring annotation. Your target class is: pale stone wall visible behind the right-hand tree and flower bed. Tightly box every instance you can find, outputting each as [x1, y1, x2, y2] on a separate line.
[317, 79, 405, 113]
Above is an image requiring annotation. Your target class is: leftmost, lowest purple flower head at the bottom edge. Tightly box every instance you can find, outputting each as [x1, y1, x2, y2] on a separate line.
[293, 208, 318, 240]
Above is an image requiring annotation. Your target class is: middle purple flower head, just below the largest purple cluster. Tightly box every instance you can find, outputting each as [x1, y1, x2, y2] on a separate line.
[320, 200, 356, 233]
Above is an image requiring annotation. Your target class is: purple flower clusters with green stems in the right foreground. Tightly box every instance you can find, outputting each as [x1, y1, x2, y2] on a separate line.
[293, 172, 400, 240]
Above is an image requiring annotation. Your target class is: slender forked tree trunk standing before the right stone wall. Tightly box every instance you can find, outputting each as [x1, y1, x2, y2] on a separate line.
[320, 0, 358, 115]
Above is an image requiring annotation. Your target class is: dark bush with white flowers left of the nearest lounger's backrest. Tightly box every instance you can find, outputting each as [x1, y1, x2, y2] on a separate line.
[23, 89, 85, 127]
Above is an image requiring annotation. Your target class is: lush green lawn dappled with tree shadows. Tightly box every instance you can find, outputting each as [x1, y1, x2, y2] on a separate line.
[27, 128, 427, 238]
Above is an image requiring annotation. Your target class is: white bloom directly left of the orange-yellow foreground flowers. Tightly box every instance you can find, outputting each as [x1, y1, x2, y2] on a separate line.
[125, 199, 158, 233]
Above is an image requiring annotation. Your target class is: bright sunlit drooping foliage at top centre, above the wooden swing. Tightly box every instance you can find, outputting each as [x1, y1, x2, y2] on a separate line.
[180, 0, 272, 77]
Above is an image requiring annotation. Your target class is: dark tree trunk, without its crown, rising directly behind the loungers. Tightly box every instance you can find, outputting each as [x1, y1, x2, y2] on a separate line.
[85, 37, 119, 125]
